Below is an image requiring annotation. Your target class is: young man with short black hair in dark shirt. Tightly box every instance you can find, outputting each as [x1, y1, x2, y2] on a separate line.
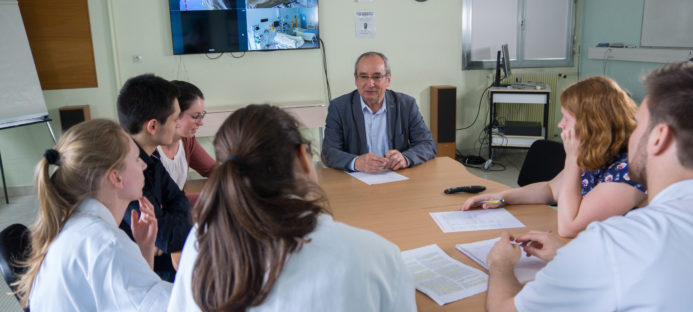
[117, 74, 192, 282]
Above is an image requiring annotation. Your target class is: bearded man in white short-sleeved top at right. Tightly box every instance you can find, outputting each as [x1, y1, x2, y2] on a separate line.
[486, 62, 693, 311]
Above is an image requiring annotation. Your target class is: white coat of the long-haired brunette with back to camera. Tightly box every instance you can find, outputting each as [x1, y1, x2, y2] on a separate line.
[168, 215, 416, 312]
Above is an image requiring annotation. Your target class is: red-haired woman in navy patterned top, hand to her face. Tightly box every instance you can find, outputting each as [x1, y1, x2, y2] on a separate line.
[460, 76, 646, 237]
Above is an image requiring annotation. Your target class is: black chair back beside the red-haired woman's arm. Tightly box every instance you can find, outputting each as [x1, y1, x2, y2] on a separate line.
[517, 140, 565, 186]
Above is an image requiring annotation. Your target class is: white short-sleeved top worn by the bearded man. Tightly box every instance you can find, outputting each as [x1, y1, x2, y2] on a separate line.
[515, 180, 693, 311]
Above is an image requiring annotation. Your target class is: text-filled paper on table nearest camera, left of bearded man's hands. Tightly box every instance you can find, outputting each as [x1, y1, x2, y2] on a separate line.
[402, 244, 488, 305]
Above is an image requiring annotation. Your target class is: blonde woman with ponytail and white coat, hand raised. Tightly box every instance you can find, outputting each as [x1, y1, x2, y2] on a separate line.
[17, 119, 171, 311]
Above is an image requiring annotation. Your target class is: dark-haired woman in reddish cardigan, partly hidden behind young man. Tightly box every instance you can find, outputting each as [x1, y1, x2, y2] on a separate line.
[156, 80, 214, 190]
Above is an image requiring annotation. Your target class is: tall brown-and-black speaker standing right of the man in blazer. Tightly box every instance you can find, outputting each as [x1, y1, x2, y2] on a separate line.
[430, 86, 457, 159]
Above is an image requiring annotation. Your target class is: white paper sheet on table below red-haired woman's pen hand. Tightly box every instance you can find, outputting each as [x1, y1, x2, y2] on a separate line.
[430, 208, 525, 233]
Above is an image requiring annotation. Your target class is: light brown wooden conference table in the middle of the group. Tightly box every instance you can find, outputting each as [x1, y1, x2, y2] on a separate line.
[186, 157, 556, 311]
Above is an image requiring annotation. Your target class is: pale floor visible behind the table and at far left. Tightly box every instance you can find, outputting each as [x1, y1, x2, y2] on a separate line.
[0, 150, 526, 312]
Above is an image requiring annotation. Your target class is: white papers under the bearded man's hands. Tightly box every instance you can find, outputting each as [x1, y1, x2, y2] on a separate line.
[455, 238, 546, 284]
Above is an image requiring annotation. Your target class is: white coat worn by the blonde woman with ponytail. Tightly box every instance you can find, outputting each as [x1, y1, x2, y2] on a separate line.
[29, 199, 172, 312]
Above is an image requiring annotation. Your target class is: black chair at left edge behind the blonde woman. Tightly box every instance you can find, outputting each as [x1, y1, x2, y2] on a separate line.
[0, 223, 31, 299]
